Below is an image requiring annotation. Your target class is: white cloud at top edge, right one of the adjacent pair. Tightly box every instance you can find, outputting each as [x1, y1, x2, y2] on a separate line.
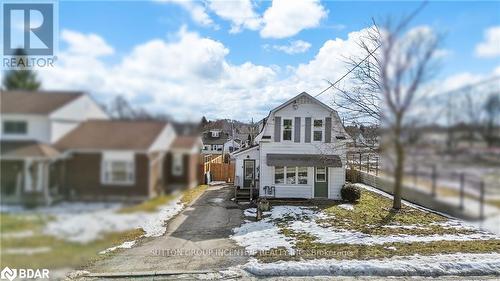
[260, 0, 328, 38]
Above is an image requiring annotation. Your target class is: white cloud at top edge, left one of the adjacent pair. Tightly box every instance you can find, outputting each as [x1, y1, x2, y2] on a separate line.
[209, 0, 262, 33]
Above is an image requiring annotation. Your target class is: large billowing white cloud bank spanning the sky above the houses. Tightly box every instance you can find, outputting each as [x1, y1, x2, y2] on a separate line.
[38, 23, 492, 121]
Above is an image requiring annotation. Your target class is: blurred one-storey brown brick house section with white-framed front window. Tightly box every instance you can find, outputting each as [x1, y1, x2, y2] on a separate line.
[55, 120, 176, 200]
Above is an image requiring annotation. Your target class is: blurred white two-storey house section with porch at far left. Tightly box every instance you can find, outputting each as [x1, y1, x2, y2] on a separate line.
[0, 91, 108, 203]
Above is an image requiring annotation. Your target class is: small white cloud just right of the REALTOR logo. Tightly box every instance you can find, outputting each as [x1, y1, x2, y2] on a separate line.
[61, 29, 114, 57]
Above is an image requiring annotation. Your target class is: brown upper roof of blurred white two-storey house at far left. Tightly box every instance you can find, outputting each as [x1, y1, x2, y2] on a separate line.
[0, 91, 83, 114]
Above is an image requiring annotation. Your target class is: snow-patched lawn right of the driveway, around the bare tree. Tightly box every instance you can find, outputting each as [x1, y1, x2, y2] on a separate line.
[232, 185, 500, 262]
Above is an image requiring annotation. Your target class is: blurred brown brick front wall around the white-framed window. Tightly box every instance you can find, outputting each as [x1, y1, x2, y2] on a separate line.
[65, 152, 149, 200]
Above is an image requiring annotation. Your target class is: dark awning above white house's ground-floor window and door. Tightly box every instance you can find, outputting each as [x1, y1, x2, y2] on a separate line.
[266, 153, 342, 168]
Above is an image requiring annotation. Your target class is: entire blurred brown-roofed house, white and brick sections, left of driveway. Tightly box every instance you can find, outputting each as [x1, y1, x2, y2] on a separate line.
[0, 92, 201, 204]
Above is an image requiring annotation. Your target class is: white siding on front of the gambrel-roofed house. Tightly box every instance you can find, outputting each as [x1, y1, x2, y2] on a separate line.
[254, 93, 346, 199]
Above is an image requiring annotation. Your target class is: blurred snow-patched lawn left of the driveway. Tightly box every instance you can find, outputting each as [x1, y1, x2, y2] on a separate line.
[0, 185, 206, 270]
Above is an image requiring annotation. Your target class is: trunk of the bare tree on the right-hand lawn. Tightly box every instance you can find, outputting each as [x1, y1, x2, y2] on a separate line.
[392, 116, 405, 210]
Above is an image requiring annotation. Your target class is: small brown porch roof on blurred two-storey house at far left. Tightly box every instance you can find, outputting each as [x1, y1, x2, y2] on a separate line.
[0, 141, 59, 158]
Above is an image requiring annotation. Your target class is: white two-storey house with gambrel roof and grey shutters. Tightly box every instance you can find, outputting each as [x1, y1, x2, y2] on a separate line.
[232, 92, 350, 199]
